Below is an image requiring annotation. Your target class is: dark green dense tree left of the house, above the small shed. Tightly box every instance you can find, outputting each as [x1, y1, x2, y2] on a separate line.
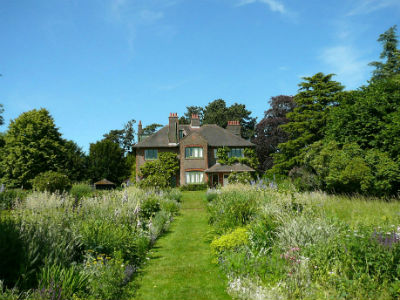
[88, 139, 130, 184]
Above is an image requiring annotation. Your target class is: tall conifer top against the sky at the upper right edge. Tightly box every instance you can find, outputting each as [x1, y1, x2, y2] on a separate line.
[369, 25, 400, 80]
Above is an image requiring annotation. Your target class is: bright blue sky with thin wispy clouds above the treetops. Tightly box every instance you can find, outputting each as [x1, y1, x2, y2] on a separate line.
[0, 0, 400, 151]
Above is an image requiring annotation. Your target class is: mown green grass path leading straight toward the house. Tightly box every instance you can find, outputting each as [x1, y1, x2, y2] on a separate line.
[135, 192, 231, 300]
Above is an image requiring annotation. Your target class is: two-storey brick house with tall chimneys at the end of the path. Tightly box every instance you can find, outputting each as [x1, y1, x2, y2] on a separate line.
[134, 113, 255, 186]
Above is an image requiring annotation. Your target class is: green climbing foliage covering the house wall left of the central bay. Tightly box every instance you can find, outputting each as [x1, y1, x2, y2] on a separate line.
[139, 152, 179, 188]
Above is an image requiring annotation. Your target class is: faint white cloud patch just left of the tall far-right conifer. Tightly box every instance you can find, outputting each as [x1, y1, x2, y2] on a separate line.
[319, 45, 370, 89]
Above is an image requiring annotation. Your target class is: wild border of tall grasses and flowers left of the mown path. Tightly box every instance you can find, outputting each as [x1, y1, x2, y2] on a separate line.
[0, 187, 180, 299]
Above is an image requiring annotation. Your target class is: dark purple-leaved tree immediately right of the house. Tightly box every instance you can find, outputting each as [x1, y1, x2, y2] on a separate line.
[252, 95, 296, 171]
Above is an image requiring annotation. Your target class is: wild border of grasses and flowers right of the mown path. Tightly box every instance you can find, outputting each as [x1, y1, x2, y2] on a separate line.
[208, 185, 400, 299]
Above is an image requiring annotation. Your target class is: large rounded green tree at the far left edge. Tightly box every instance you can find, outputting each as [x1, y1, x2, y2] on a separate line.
[1, 108, 64, 187]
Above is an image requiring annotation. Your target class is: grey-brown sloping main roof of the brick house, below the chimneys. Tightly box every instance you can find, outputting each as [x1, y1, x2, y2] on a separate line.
[134, 124, 254, 148]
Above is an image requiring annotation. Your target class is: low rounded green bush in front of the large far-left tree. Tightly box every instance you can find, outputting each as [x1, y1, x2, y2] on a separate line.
[32, 171, 71, 193]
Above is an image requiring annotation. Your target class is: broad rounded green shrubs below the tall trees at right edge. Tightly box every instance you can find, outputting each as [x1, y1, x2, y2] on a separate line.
[302, 142, 399, 196]
